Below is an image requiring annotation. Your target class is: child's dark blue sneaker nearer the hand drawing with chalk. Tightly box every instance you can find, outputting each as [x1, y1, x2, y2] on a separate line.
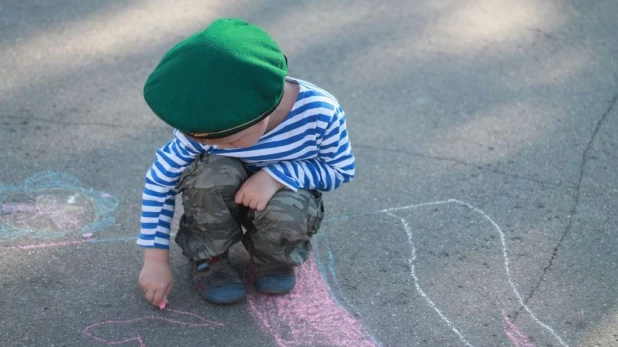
[191, 256, 247, 304]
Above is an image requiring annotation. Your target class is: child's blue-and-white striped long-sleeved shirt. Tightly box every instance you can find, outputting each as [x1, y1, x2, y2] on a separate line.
[137, 79, 355, 249]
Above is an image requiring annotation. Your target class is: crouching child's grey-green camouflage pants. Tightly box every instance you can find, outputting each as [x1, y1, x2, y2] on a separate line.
[175, 154, 324, 266]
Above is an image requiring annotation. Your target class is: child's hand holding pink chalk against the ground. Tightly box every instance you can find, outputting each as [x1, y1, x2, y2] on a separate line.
[138, 249, 174, 306]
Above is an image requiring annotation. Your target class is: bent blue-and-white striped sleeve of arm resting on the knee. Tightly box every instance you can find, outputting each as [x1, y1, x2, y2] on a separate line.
[264, 106, 355, 191]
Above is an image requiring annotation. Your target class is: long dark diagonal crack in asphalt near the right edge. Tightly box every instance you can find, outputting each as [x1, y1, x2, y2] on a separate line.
[513, 93, 618, 321]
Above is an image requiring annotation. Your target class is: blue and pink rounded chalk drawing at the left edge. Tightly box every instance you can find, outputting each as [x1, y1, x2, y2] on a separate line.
[0, 172, 118, 242]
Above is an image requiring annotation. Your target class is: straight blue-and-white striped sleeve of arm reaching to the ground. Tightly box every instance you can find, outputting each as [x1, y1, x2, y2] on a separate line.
[137, 130, 204, 249]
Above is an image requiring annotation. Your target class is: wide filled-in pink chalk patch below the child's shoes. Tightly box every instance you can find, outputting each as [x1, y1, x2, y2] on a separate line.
[248, 256, 376, 347]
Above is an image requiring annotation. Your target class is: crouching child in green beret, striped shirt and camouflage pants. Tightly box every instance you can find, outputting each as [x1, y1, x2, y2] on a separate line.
[137, 19, 355, 306]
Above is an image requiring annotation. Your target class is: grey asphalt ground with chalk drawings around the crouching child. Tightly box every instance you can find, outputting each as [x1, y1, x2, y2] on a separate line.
[0, 0, 618, 347]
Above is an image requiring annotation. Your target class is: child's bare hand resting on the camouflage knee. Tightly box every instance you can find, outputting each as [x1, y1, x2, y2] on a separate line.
[234, 170, 285, 211]
